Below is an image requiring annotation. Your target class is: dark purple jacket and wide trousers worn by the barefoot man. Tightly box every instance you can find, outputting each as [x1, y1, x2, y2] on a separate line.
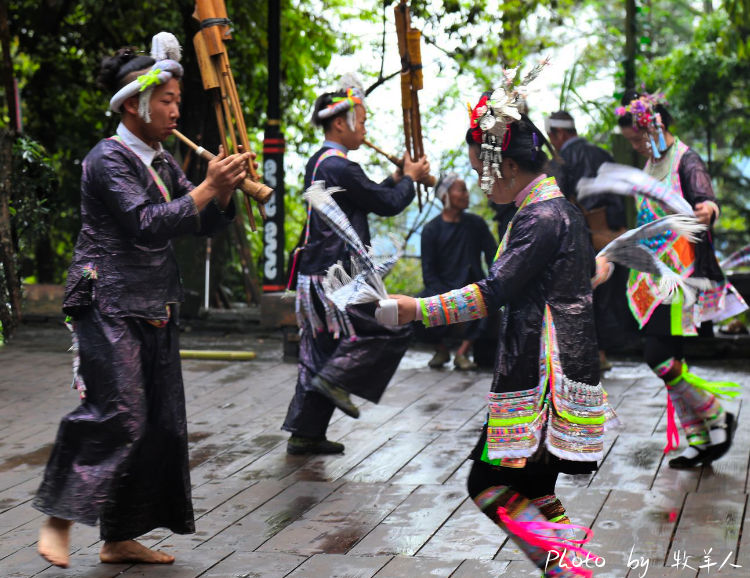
[33, 139, 235, 541]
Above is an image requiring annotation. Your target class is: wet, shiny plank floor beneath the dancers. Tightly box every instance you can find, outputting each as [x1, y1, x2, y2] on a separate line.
[0, 323, 750, 578]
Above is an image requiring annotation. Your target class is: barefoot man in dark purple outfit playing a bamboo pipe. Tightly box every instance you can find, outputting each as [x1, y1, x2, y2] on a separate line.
[33, 33, 250, 567]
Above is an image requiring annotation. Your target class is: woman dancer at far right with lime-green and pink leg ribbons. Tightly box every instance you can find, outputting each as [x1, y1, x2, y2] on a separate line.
[615, 91, 747, 469]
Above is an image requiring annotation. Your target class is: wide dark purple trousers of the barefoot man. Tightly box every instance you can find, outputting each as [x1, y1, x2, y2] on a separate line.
[33, 306, 195, 541]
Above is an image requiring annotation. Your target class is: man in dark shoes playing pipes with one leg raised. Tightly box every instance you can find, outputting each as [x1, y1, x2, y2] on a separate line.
[282, 77, 429, 454]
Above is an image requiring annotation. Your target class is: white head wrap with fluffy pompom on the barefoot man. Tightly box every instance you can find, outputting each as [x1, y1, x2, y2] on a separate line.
[109, 32, 183, 122]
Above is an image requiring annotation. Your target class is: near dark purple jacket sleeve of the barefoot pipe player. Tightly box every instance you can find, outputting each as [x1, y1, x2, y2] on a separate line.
[90, 145, 201, 242]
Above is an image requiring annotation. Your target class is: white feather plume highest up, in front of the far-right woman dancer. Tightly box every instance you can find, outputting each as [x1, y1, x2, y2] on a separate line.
[578, 163, 695, 216]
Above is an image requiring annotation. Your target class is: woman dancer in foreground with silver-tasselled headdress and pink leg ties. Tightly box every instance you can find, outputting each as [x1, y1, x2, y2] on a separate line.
[394, 89, 614, 576]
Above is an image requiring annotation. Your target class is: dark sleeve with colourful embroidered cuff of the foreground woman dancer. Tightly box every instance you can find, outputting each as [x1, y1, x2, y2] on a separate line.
[418, 208, 559, 327]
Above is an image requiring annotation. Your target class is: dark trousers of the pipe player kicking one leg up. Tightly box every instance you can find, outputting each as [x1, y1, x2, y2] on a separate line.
[281, 296, 411, 438]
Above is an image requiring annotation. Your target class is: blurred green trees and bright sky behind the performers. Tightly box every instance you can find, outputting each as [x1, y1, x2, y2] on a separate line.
[0, 0, 750, 322]
